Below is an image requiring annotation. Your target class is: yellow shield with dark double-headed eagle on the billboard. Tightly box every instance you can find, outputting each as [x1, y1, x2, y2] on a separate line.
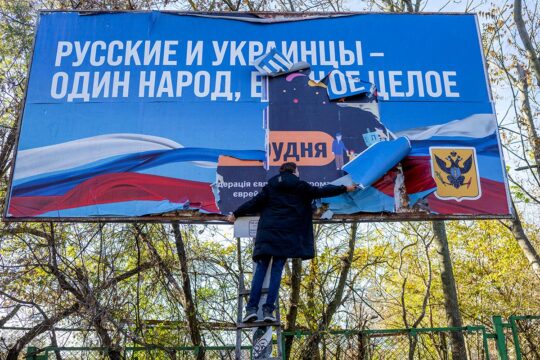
[429, 147, 482, 201]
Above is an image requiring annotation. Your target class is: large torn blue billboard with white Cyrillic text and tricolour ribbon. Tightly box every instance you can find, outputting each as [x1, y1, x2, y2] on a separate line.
[4, 11, 511, 221]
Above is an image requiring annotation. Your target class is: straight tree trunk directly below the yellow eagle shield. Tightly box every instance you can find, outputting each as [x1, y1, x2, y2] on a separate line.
[433, 220, 467, 360]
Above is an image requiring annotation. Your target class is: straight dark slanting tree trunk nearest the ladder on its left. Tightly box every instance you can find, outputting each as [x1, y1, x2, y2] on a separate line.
[172, 222, 205, 360]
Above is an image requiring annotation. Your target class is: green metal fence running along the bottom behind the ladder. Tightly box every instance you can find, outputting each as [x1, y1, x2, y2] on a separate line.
[16, 315, 540, 360]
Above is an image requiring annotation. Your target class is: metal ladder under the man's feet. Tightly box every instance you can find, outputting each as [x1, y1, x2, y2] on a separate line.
[235, 238, 283, 360]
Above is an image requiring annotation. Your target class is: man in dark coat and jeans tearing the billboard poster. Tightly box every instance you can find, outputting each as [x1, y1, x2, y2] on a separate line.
[227, 162, 356, 322]
